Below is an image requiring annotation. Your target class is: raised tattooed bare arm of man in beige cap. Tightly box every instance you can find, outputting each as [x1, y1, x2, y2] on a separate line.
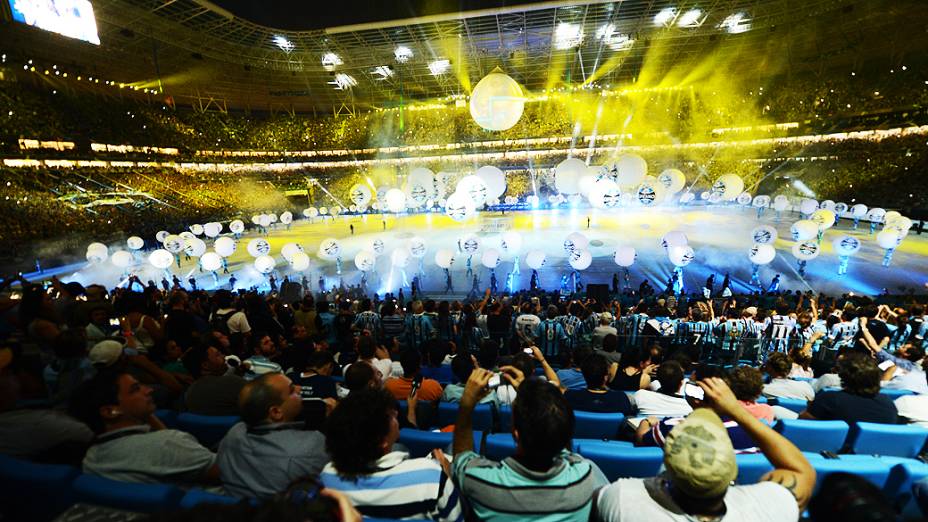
[698, 377, 815, 511]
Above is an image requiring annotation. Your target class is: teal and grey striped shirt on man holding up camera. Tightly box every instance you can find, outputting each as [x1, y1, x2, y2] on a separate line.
[451, 451, 609, 522]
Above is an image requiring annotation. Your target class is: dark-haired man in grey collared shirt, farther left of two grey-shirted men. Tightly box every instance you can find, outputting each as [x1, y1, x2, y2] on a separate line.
[70, 370, 219, 484]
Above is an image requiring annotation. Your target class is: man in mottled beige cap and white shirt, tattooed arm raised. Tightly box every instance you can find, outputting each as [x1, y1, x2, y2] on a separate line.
[594, 377, 815, 522]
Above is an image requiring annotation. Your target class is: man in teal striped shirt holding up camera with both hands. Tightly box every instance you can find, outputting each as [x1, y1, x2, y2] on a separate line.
[452, 366, 608, 521]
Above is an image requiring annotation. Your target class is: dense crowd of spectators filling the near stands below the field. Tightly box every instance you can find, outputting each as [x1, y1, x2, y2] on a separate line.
[0, 266, 928, 521]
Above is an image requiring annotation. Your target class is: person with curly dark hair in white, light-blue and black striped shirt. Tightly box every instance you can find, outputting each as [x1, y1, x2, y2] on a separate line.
[319, 388, 461, 521]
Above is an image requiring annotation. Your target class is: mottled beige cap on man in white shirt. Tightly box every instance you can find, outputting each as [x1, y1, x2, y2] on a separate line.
[664, 408, 738, 498]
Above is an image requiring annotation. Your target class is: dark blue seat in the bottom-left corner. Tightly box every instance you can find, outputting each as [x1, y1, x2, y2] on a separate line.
[0, 455, 81, 521]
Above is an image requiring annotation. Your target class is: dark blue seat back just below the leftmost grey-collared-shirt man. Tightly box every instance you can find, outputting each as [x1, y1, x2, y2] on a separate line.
[73, 475, 184, 513]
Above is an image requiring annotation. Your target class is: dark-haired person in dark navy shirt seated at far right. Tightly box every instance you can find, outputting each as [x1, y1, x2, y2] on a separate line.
[799, 353, 899, 424]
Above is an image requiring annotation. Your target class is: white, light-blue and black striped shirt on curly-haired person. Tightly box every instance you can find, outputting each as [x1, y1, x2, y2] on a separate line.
[319, 451, 463, 521]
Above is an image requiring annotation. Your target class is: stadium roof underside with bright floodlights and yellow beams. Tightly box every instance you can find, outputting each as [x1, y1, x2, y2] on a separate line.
[0, 0, 928, 111]
